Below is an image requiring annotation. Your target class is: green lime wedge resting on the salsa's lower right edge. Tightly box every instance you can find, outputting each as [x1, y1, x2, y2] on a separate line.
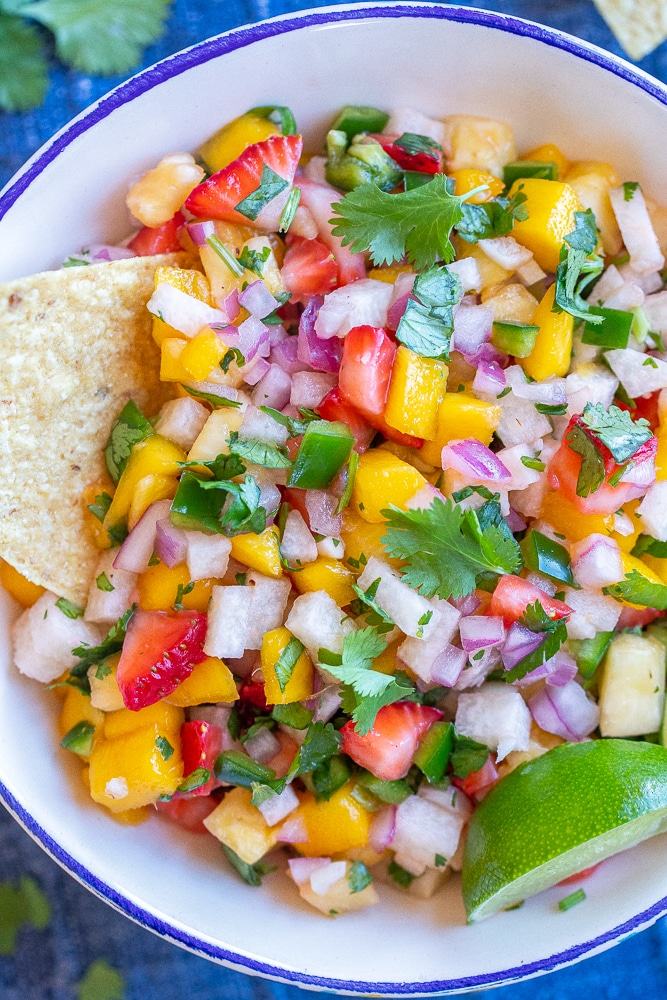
[461, 739, 667, 922]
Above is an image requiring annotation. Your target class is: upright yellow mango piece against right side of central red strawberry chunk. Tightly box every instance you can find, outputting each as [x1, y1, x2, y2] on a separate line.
[384, 344, 447, 440]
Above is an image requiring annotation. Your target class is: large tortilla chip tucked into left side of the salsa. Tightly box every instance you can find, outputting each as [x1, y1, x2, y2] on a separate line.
[0, 254, 192, 605]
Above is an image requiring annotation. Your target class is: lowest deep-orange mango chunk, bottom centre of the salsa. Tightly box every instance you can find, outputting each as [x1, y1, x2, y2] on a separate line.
[292, 781, 371, 858]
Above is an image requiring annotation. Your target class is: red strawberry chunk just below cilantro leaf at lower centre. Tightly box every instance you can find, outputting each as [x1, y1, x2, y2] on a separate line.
[340, 701, 442, 781]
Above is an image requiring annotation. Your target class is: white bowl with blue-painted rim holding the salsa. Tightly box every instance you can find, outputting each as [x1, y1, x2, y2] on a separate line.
[0, 3, 667, 996]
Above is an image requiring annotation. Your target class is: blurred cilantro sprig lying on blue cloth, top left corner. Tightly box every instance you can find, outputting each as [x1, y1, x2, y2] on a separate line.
[0, 0, 170, 111]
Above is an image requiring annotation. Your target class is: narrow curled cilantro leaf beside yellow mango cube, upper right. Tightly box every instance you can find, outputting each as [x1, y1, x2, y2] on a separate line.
[553, 208, 604, 323]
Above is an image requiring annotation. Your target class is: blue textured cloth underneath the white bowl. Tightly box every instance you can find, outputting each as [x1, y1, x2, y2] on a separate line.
[0, 0, 667, 1000]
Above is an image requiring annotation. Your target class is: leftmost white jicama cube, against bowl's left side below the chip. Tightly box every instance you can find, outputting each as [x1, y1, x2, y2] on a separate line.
[12, 590, 103, 684]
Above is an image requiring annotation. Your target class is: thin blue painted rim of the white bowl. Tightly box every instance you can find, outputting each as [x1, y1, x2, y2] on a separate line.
[0, 2, 667, 996]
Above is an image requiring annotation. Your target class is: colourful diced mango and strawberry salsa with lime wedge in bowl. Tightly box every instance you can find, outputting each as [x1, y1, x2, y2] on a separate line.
[3, 106, 667, 920]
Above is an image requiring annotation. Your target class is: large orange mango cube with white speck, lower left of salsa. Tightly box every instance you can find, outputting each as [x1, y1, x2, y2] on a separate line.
[90, 709, 183, 812]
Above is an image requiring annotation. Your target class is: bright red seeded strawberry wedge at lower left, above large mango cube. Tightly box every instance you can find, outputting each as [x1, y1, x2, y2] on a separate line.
[116, 610, 206, 712]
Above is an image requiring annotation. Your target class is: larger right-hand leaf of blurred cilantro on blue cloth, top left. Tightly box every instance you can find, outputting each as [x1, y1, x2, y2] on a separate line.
[24, 0, 169, 76]
